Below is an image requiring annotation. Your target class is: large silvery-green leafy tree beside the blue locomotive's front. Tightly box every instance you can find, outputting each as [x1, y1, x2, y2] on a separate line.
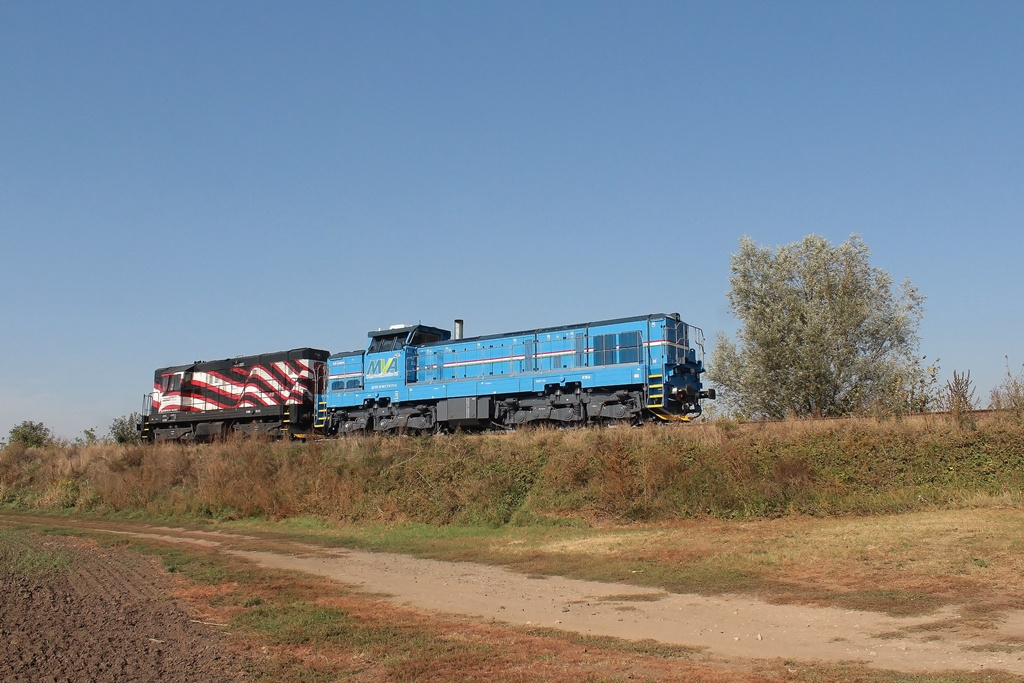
[708, 234, 937, 418]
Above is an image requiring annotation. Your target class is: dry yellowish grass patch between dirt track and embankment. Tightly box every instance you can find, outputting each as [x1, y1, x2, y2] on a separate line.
[512, 507, 1024, 615]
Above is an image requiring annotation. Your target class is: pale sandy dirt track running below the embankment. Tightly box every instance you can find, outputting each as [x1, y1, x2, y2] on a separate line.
[6, 515, 1024, 676]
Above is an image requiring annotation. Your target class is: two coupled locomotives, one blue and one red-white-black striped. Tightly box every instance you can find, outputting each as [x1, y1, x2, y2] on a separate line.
[139, 313, 715, 442]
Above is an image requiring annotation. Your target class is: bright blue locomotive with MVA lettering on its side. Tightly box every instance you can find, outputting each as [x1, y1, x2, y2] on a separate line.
[316, 313, 715, 435]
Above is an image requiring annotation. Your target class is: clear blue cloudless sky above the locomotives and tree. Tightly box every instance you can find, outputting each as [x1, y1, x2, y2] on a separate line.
[0, 0, 1024, 437]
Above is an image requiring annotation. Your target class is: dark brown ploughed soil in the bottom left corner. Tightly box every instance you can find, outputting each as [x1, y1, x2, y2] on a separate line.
[0, 535, 253, 683]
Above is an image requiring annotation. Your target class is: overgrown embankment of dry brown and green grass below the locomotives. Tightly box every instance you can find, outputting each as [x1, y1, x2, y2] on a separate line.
[0, 415, 1024, 526]
